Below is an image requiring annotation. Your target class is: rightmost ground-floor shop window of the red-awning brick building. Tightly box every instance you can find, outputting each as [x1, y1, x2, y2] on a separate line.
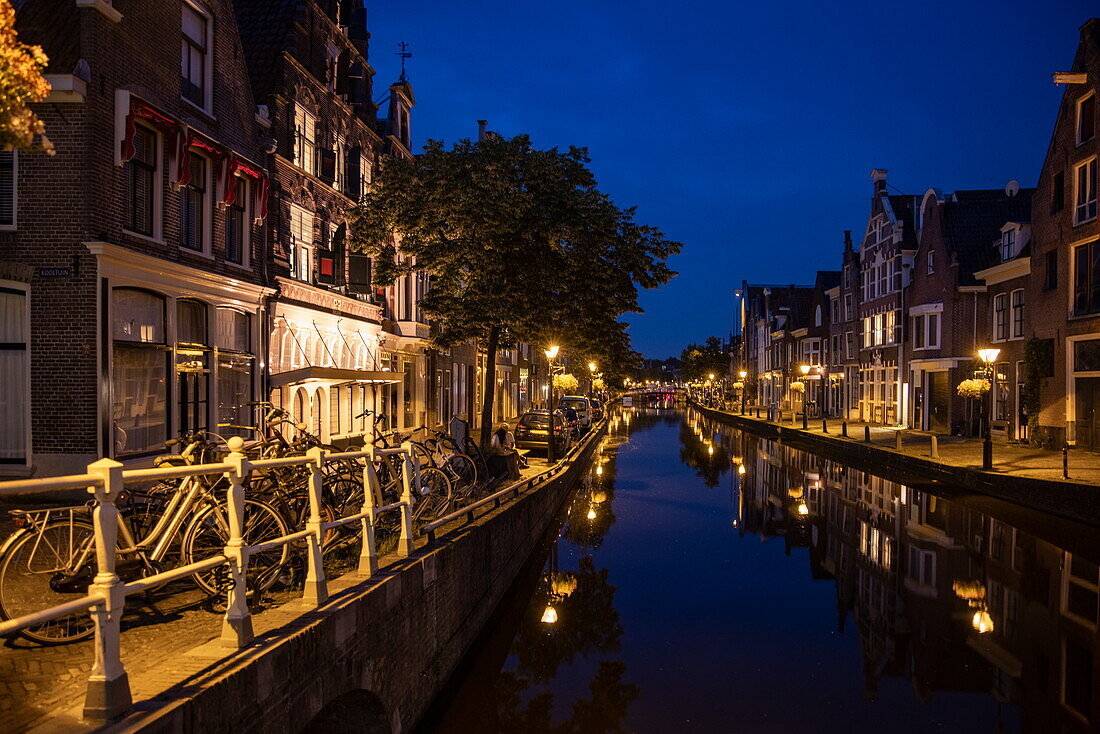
[215, 308, 255, 436]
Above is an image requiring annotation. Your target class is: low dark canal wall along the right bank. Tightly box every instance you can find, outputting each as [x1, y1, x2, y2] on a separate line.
[689, 401, 1100, 527]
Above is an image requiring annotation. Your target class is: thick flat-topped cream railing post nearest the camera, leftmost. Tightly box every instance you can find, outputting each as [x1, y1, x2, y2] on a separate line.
[84, 459, 133, 720]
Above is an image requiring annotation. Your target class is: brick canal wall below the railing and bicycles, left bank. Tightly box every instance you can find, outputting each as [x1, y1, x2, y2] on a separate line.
[80, 421, 606, 734]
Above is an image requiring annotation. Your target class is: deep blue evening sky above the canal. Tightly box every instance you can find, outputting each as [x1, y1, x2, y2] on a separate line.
[366, 0, 1100, 357]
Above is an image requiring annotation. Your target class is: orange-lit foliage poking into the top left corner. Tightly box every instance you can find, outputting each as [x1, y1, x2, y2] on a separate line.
[0, 0, 54, 155]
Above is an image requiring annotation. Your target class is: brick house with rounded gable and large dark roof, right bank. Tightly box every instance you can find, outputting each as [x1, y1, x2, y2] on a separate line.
[904, 187, 1032, 436]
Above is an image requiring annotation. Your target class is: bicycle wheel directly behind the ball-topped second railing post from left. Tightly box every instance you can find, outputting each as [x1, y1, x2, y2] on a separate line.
[183, 500, 290, 596]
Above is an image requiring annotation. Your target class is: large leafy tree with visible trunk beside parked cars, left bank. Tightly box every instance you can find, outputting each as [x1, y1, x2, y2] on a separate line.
[349, 135, 680, 442]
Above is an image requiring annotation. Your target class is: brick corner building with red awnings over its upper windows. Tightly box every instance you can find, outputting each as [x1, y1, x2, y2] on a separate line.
[0, 0, 270, 474]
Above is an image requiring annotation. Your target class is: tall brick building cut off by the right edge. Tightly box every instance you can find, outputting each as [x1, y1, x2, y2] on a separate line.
[1026, 19, 1100, 449]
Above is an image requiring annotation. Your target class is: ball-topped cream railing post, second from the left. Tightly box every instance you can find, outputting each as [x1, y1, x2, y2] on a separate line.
[221, 436, 254, 647]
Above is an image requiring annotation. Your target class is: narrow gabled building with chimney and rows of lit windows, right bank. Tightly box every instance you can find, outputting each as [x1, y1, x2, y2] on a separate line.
[859, 168, 920, 425]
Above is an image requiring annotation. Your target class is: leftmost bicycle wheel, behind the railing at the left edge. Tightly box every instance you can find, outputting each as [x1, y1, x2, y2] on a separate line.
[0, 521, 97, 645]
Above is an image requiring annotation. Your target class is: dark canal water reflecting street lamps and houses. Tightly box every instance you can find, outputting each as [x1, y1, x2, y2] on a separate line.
[419, 403, 1100, 734]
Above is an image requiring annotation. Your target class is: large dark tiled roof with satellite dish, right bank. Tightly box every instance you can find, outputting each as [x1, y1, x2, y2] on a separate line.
[944, 188, 1035, 285]
